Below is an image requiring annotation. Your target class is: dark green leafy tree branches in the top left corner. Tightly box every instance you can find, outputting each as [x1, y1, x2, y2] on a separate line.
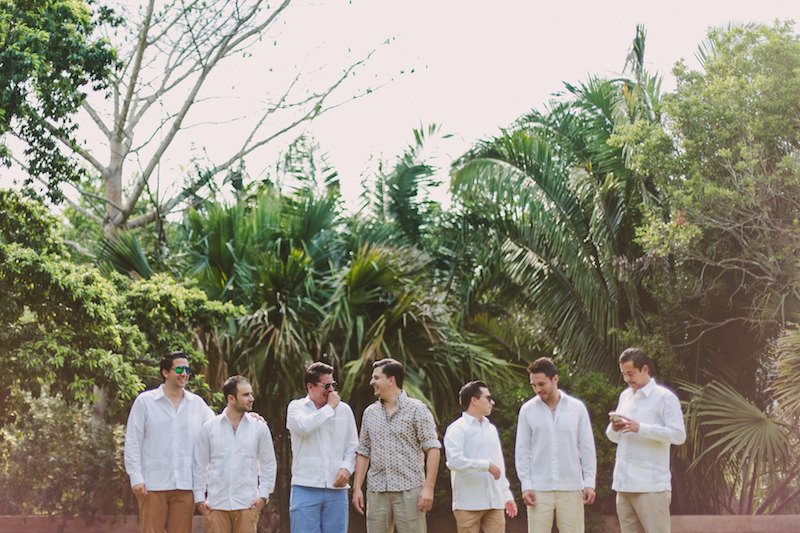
[0, 0, 115, 198]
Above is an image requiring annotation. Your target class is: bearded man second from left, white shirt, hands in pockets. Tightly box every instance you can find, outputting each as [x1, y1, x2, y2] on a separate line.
[194, 376, 277, 533]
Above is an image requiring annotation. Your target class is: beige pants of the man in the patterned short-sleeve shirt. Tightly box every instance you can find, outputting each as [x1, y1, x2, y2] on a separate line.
[367, 487, 428, 533]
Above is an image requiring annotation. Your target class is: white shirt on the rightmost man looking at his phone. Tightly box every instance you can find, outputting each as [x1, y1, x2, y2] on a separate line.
[606, 378, 686, 492]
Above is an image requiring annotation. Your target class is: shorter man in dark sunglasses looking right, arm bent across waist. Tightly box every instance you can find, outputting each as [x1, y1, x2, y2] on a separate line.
[444, 381, 517, 533]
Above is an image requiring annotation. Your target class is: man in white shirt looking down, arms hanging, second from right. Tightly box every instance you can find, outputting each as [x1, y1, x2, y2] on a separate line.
[515, 357, 597, 533]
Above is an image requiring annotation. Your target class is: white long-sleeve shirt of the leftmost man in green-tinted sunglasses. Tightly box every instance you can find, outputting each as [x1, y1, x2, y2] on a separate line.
[125, 385, 214, 490]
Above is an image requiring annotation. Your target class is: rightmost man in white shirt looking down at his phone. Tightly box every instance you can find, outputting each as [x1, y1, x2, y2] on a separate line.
[606, 348, 686, 533]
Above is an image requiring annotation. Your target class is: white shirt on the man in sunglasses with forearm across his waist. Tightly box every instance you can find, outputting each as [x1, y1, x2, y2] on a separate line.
[444, 413, 514, 511]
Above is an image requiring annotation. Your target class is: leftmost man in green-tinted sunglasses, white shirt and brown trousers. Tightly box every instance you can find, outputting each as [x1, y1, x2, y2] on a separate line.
[125, 352, 214, 533]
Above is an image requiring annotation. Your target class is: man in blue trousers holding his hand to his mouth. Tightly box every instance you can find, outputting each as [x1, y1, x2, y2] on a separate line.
[286, 362, 358, 533]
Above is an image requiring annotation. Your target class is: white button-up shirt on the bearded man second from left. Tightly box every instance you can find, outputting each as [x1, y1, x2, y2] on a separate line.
[194, 408, 278, 511]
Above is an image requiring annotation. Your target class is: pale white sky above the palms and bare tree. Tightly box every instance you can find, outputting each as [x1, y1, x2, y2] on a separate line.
[0, 0, 800, 210]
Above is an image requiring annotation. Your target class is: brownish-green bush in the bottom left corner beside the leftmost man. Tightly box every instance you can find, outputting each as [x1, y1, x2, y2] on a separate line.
[0, 392, 132, 518]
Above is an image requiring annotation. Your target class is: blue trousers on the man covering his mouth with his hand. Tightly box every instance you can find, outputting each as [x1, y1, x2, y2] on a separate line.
[289, 485, 349, 533]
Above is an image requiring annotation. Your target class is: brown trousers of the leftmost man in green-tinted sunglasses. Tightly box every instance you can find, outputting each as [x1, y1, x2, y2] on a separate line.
[137, 490, 194, 533]
